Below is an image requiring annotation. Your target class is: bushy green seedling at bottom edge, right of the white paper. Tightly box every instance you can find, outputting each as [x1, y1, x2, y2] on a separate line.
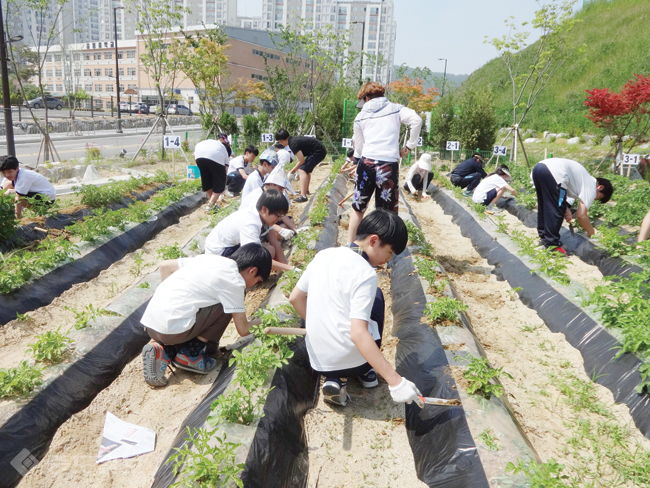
[167, 427, 246, 488]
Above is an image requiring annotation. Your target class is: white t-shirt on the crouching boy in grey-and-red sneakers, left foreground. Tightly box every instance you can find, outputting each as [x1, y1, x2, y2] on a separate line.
[141, 254, 246, 334]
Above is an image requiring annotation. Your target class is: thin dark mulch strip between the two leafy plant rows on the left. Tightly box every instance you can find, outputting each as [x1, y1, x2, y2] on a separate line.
[0, 184, 169, 252]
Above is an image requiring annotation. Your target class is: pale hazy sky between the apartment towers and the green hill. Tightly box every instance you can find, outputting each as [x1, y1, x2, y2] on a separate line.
[238, 0, 582, 75]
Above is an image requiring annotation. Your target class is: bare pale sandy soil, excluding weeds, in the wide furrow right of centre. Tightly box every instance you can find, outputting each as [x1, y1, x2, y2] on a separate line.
[409, 188, 650, 480]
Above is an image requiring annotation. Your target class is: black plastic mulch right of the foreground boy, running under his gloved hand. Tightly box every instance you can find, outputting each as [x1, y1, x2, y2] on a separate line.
[390, 250, 489, 488]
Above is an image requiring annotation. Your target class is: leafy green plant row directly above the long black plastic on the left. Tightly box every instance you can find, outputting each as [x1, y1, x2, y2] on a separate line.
[0, 180, 199, 294]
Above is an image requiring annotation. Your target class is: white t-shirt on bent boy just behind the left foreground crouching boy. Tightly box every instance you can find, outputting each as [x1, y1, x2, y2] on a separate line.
[205, 205, 262, 255]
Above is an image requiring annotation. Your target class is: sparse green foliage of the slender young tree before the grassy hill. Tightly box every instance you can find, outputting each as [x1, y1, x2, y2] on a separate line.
[486, 0, 581, 158]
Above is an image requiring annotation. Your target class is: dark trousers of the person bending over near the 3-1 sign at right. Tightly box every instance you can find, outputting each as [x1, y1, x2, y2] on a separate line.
[533, 163, 568, 247]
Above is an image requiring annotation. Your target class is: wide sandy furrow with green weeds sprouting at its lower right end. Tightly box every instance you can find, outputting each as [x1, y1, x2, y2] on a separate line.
[404, 180, 649, 486]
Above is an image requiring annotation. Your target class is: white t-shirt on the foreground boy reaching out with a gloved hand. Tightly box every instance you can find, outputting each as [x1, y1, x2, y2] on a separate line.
[297, 247, 379, 371]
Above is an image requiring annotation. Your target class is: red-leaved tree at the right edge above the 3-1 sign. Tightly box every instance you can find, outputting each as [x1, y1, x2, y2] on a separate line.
[585, 74, 650, 170]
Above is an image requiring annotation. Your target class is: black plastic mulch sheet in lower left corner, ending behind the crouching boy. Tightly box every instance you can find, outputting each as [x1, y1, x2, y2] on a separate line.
[0, 300, 149, 488]
